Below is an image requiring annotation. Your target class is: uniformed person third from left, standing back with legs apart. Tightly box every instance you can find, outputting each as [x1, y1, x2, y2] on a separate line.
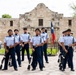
[21, 28, 30, 61]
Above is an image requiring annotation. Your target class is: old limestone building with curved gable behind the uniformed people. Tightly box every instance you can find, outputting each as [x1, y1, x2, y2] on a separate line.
[0, 3, 76, 41]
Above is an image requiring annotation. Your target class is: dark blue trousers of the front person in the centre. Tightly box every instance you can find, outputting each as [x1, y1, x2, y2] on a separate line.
[32, 47, 43, 69]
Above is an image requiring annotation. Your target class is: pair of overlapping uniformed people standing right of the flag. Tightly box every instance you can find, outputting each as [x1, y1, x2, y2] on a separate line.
[58, 29, 76, 71]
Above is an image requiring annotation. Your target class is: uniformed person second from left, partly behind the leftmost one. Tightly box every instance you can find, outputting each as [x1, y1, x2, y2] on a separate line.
[14, 29, 22, 67]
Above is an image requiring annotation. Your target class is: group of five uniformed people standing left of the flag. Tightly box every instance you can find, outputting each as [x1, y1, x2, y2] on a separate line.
[2, 27, 49, 71]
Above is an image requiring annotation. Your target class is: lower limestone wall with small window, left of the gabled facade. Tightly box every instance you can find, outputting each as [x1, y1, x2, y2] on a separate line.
[0, 18, 19, 41]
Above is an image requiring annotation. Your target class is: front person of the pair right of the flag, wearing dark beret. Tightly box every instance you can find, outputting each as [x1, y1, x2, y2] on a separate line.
[62, 29, 75, 71]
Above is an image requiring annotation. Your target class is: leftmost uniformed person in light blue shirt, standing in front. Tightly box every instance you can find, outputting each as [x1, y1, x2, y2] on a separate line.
[3, 29, 18, 71]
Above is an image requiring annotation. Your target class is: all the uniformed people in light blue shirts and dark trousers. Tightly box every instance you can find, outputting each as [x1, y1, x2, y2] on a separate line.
[2, 27, 76, 71]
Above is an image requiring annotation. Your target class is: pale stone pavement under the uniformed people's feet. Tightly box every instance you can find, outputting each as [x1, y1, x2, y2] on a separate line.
[0, 52, 76, 75]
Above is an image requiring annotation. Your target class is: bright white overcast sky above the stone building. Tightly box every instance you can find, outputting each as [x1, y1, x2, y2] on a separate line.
[0, 0, 76, 18]
